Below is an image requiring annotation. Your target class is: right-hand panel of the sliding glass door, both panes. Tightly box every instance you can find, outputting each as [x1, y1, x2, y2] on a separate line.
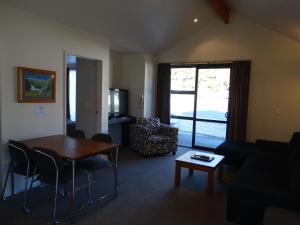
[194, 68, 230, 148]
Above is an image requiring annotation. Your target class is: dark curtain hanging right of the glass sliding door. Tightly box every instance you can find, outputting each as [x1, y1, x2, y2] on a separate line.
[227, 61, 251, 141]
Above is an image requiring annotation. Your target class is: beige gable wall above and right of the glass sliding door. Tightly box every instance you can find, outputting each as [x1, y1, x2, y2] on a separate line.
[159, 15, 300, 141]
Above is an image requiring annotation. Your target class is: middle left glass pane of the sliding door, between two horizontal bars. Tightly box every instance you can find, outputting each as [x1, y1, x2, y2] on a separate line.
[171, 94, 195, 117]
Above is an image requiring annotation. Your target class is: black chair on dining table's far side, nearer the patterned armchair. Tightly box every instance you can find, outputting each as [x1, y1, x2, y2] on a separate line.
[77, 133, 118, 203]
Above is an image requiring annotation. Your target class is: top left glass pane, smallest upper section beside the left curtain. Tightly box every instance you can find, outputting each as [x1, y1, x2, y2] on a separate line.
[171, 68, 196, 91]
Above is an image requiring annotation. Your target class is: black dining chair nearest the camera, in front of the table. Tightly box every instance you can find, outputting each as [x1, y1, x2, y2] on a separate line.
[30, 147, 89, 224]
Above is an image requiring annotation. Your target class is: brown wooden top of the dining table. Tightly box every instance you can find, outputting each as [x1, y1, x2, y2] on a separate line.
[21, 135, 118, 160]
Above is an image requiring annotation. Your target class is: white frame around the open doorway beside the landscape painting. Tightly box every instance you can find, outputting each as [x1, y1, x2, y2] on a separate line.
[63, 51, 103, 135]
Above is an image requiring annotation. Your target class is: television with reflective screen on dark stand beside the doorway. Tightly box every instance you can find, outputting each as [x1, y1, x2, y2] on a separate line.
[108, 89, 128, 117]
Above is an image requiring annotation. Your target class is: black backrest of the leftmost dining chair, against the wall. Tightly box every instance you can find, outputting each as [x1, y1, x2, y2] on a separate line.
[8, 140, 33, 166]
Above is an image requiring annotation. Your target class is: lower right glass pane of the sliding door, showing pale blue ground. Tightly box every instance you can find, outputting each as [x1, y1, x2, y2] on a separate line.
[195, 121, 226, 148]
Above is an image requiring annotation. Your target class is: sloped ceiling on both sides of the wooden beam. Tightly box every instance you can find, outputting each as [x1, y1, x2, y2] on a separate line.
[0, 0, 300, 54]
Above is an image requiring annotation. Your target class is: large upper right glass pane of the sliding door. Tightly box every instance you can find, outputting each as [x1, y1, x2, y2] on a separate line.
[196, 68, 230, 121]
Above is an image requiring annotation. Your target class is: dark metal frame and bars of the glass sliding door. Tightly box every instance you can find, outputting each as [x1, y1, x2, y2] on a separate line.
[170, 63, 232, 151]
